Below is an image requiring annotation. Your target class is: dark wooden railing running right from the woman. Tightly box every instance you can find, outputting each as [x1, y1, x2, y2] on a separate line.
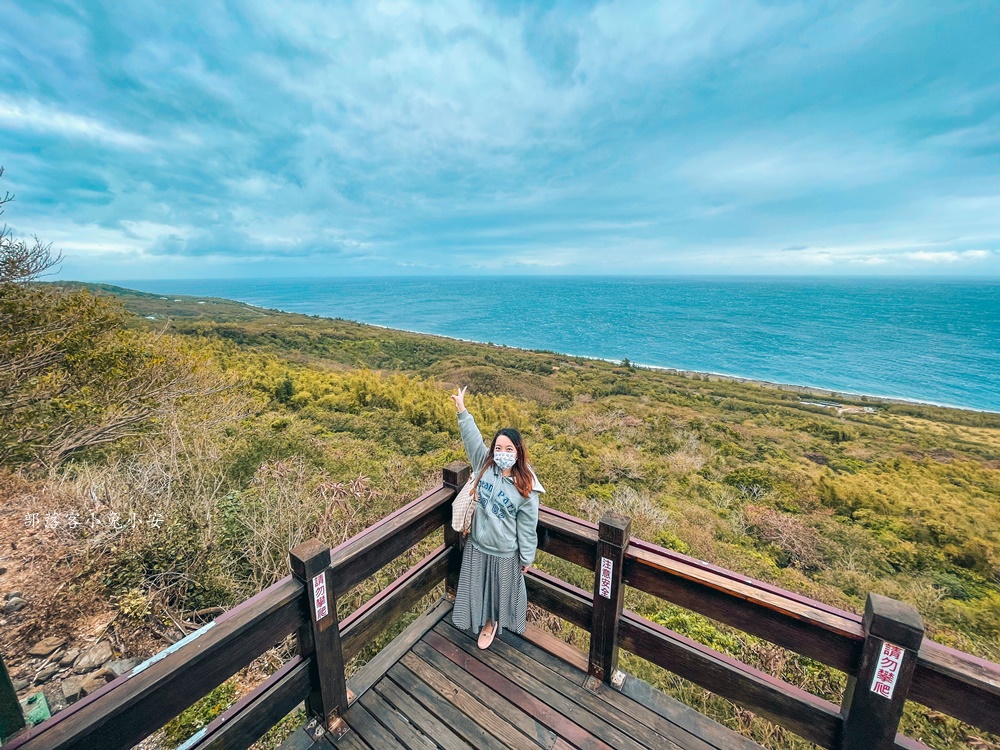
[527, 508, 1000, 748]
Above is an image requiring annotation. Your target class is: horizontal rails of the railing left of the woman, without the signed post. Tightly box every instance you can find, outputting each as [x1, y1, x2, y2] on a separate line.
[5, 478, 454, 750]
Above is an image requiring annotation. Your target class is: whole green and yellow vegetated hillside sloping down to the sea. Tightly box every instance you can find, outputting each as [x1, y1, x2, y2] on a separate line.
[0, 274, 1000, 748]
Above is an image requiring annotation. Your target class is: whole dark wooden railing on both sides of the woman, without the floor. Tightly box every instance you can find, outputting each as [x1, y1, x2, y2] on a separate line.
[4, 463, 1000, 750]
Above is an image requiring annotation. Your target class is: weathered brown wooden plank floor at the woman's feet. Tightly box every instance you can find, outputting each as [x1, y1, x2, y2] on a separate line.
[299, 602, 761, 750]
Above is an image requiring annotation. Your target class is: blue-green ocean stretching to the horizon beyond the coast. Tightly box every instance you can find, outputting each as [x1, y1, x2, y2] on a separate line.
[112, 276, 1000, 412]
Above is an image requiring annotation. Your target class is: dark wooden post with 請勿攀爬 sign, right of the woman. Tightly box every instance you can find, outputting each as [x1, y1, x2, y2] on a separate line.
[841, 594, 924, 750]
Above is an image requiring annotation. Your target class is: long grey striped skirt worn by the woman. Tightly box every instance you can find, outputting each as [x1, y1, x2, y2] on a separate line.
[451, 541, 528, 635]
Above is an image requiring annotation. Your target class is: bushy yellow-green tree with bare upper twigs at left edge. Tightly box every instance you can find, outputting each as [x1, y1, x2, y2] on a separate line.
[0, 170, 209, 464]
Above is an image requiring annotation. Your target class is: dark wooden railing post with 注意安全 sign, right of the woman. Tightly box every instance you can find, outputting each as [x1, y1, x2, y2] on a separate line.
[587, 513, 632, 683]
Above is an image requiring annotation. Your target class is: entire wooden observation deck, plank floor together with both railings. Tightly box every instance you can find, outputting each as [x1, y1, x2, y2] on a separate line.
[0, 464, 1000, 750]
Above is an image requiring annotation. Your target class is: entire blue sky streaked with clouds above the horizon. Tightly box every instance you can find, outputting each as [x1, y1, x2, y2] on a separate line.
[0, 0, 1000, 280]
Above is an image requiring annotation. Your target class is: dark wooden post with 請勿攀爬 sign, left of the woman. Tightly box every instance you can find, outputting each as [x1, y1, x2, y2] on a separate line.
[288, 539, 348, 734]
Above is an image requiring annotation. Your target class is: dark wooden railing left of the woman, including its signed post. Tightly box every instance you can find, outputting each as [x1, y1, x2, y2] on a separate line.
[3, 471, 455, 750]
